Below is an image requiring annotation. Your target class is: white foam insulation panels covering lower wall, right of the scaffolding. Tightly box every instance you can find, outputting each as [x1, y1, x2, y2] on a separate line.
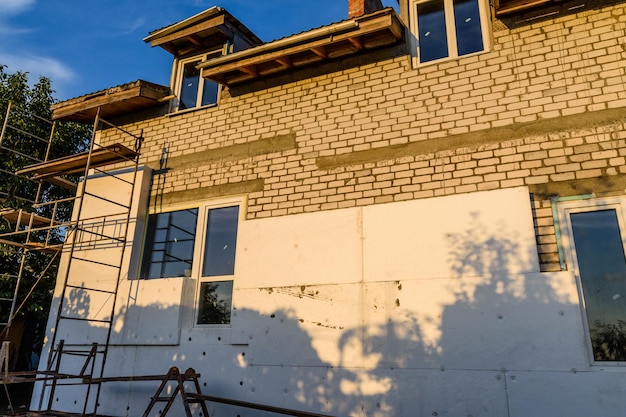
[34, 187, 626, 417]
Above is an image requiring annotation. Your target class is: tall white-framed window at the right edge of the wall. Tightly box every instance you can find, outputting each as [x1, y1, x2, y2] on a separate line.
[558, 198, 626, 362]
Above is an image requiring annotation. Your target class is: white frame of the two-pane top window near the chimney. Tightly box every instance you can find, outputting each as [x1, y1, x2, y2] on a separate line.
[409, 0, 493, 68]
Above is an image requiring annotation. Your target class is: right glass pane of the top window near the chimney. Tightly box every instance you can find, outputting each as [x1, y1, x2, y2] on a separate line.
[454, 0, 484, 55]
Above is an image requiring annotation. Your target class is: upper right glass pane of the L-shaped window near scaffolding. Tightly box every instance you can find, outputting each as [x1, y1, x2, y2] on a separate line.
[202, 206, 239, 277]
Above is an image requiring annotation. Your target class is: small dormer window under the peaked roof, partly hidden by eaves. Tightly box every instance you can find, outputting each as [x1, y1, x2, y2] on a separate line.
[176, 51, 222, 110]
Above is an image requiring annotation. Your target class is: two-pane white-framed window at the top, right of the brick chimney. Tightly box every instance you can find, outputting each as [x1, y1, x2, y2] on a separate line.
[411, 0, 489, 65]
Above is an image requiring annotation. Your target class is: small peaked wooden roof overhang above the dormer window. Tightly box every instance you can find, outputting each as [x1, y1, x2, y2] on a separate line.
[144, 6, 263, 57]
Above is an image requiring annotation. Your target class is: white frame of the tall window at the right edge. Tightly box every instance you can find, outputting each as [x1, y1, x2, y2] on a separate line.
[556, 196, 626, 367]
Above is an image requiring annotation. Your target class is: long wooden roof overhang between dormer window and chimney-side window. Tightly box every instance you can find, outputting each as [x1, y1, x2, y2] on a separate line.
[198, 8, 405, 85]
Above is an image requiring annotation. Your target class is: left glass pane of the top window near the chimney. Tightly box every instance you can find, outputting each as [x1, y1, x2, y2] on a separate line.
[417, 1, 448, 62]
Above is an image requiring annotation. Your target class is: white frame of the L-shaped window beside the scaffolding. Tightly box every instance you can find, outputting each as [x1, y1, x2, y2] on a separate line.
[137, 197, 247, 328]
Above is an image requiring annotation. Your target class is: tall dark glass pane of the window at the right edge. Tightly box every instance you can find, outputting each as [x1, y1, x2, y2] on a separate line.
[570, 210, 626, 361]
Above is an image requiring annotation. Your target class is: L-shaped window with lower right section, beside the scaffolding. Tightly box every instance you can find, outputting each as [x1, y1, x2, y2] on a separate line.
[140, 205, 240, 325]
